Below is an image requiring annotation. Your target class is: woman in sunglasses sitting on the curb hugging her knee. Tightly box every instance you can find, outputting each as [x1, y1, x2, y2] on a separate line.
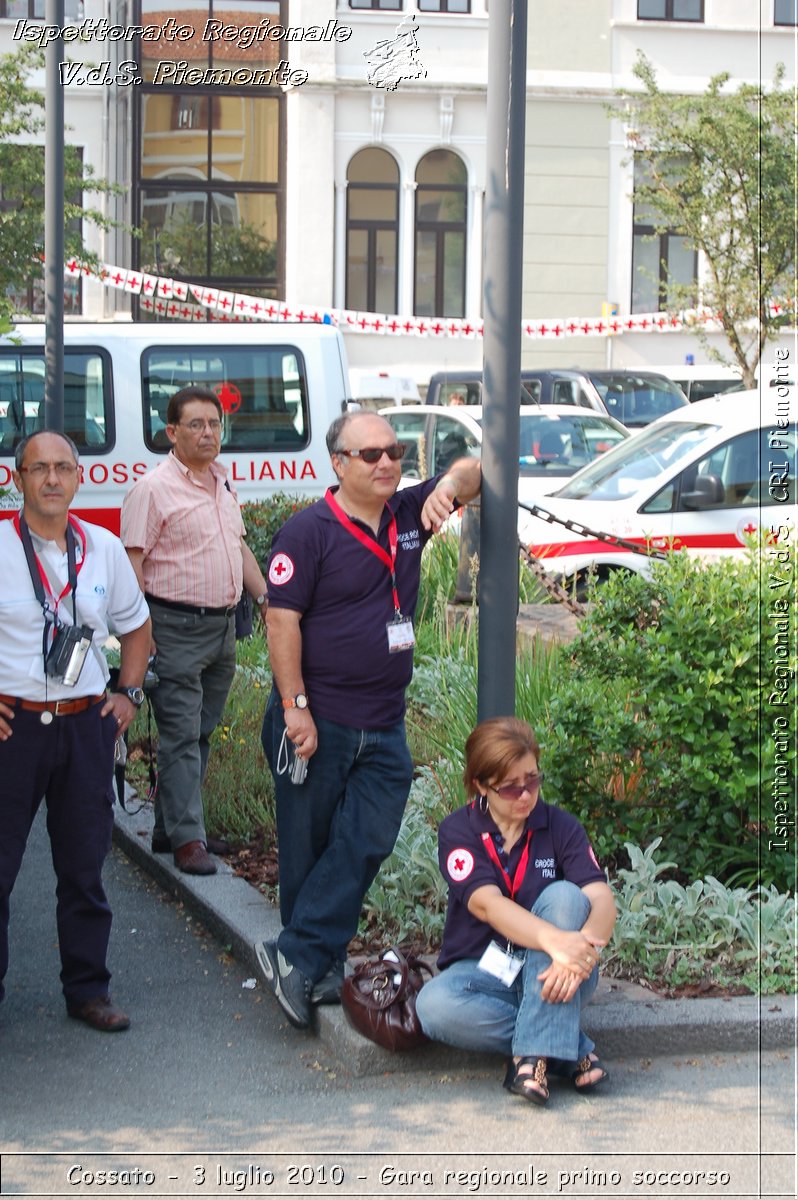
[418, 716, 616, 1104]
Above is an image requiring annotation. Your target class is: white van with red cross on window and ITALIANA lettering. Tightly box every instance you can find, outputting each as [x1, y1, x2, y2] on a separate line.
[0, 323, 348, 533]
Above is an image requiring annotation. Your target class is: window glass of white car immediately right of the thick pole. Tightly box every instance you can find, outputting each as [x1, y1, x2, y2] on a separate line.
[472, 412, 625, 475]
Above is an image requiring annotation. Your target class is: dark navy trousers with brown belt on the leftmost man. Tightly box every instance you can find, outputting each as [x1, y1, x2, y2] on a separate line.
[0, 704, 116, 1004]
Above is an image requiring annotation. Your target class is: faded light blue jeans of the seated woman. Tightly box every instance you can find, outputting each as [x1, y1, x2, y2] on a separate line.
[416, 880, 599, 1062]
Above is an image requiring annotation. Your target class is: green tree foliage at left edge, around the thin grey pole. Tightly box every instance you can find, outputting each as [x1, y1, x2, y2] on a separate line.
[0, 44, 122, 332]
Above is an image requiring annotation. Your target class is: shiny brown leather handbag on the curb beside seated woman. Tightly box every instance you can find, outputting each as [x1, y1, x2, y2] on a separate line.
[341, 946, 432, 1050]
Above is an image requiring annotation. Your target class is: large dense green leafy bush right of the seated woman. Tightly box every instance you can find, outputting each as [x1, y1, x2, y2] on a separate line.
[537, 554, 794, 890]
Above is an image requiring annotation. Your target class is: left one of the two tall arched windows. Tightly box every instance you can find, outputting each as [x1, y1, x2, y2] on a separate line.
[346, 149, 398, 312]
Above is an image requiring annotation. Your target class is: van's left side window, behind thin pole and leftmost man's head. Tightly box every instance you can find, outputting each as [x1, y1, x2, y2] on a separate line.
[0, 348, 114, 455]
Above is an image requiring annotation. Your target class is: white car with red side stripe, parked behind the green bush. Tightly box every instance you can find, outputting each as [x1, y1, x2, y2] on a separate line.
[522, 386, 798, 580]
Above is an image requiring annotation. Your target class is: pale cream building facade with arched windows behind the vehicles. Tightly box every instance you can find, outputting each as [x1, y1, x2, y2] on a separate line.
[0, 0, 796, 384]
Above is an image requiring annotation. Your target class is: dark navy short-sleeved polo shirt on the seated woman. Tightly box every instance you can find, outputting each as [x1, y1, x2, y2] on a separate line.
[438, 800, 607, 968]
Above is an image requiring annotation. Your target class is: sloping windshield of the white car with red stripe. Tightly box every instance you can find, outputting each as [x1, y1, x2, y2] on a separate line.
[554, 421, 719, 500]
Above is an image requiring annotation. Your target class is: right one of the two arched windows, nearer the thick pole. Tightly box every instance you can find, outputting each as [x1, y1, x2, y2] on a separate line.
[413, 150, 468, 317]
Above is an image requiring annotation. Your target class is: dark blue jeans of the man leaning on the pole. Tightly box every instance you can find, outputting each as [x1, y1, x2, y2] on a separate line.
[262, 691, 413, 982]
